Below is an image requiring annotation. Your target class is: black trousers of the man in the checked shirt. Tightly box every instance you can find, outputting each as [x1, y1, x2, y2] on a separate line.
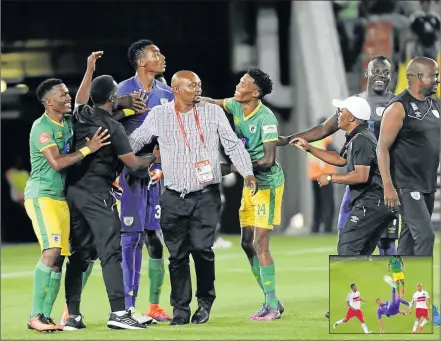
[160, 185, 221, 318]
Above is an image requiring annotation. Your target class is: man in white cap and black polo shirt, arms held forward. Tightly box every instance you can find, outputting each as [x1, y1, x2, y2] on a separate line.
[294, 96, 395, 255]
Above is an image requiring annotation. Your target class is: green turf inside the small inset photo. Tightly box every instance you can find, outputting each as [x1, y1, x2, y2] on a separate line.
[329, 256, 434, 334]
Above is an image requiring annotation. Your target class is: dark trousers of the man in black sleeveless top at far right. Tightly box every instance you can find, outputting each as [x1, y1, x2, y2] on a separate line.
[397, 190, 435, 256]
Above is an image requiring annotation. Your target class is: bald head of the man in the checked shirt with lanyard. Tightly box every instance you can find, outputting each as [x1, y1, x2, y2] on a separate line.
[171, 70, 202, 105]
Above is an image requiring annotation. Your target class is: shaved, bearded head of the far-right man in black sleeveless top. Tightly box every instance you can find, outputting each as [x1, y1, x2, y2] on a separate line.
[406, 57, 439, 97]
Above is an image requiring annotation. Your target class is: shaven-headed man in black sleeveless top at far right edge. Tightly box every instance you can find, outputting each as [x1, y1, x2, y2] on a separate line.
[377, 57, 441, 256]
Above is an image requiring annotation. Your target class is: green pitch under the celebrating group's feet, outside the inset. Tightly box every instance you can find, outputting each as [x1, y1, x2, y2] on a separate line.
[1, 236, 439, 340]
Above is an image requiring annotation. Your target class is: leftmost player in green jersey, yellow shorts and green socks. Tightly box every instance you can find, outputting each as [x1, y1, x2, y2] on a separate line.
[25, 78, 109, 331]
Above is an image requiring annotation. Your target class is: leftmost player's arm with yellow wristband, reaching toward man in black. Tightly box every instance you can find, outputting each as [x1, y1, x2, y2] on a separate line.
[37, 126, 110, 172]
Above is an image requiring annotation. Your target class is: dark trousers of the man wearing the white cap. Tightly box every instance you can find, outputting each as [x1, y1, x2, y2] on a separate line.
[338, 200, 396, 256]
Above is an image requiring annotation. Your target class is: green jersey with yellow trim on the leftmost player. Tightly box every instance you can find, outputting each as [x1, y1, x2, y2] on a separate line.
[25, 113, 72, 200]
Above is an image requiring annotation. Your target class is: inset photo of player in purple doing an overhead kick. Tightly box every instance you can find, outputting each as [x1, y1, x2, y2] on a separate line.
[329, 256, 436, 334]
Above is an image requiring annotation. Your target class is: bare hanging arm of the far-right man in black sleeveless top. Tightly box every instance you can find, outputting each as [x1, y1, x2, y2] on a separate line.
[377, 103, 405, 208]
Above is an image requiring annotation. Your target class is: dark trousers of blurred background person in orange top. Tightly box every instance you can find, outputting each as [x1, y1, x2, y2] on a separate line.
[311, 180, 335, 233]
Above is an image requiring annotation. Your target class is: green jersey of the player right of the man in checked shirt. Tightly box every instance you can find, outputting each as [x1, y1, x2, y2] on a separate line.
[224, 98, 285, 189]
